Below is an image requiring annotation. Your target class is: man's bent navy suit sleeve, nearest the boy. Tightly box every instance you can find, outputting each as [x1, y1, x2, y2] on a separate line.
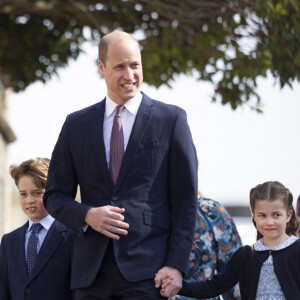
[44, 116, 91, 235]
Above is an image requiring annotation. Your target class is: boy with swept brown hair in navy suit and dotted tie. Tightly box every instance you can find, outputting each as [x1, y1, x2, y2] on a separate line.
[0, 158, 73, 300]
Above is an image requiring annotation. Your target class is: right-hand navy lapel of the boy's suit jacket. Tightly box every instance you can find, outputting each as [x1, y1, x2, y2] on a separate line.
[28, 221, 66, 281]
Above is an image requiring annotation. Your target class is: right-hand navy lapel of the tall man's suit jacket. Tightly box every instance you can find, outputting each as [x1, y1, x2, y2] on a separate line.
[115, 94, 153, 190]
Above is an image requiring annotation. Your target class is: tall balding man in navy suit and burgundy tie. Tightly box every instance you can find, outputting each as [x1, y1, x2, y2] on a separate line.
[44, 31, 197, 300]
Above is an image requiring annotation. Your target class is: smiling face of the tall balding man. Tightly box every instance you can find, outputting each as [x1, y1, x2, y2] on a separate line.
[98, 38, 143, 104]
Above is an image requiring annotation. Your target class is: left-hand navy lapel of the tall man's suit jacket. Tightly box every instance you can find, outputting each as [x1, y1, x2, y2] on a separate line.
[90, 99, 114, 190]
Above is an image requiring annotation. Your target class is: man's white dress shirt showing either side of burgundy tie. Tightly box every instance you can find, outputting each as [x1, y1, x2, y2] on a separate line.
[103, 92, 143, 168]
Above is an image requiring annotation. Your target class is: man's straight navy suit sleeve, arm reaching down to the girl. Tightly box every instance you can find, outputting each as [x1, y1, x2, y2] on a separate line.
[166, 110, 198, 275]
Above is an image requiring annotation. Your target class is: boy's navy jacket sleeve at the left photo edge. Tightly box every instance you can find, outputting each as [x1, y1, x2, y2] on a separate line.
[0, 236, 11, 300]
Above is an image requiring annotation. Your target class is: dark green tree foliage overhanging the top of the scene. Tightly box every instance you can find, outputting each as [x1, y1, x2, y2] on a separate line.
[0, 0, 300, 112]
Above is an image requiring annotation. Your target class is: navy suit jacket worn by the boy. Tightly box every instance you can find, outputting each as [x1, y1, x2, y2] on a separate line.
[0, 221, 74, 300]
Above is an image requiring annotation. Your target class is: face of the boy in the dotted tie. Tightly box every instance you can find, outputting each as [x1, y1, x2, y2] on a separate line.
[18, 175, 48, 222]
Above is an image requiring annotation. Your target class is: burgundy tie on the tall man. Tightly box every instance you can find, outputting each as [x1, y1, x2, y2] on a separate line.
[109, 105, 125, 184]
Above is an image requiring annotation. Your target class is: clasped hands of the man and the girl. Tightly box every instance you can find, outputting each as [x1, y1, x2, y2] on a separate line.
[154, 266, 182, 298]
